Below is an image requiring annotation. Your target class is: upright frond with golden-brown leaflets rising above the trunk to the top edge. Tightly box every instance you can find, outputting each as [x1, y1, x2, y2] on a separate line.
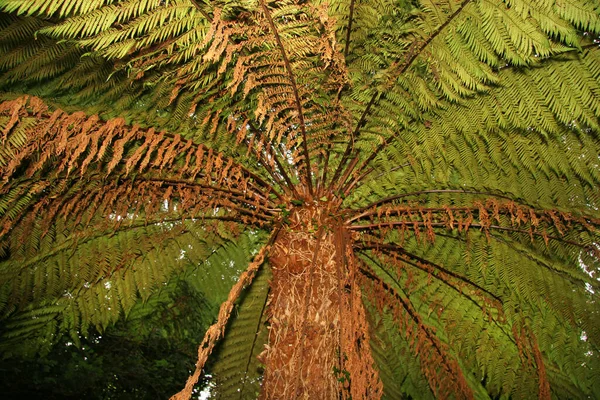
[178, 2, 351, 198]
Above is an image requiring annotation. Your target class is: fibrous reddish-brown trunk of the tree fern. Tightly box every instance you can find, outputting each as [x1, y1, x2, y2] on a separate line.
[261, 208, 382, 400]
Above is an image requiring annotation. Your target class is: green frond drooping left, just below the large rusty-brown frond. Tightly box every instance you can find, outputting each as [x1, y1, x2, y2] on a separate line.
[0, 228, 257, 352]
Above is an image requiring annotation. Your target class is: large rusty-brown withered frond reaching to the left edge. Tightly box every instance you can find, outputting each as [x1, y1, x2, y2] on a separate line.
[0, 98, 277, 238]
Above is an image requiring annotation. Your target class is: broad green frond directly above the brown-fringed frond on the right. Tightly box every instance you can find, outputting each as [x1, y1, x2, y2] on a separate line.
[355, 49, 600, 215]
